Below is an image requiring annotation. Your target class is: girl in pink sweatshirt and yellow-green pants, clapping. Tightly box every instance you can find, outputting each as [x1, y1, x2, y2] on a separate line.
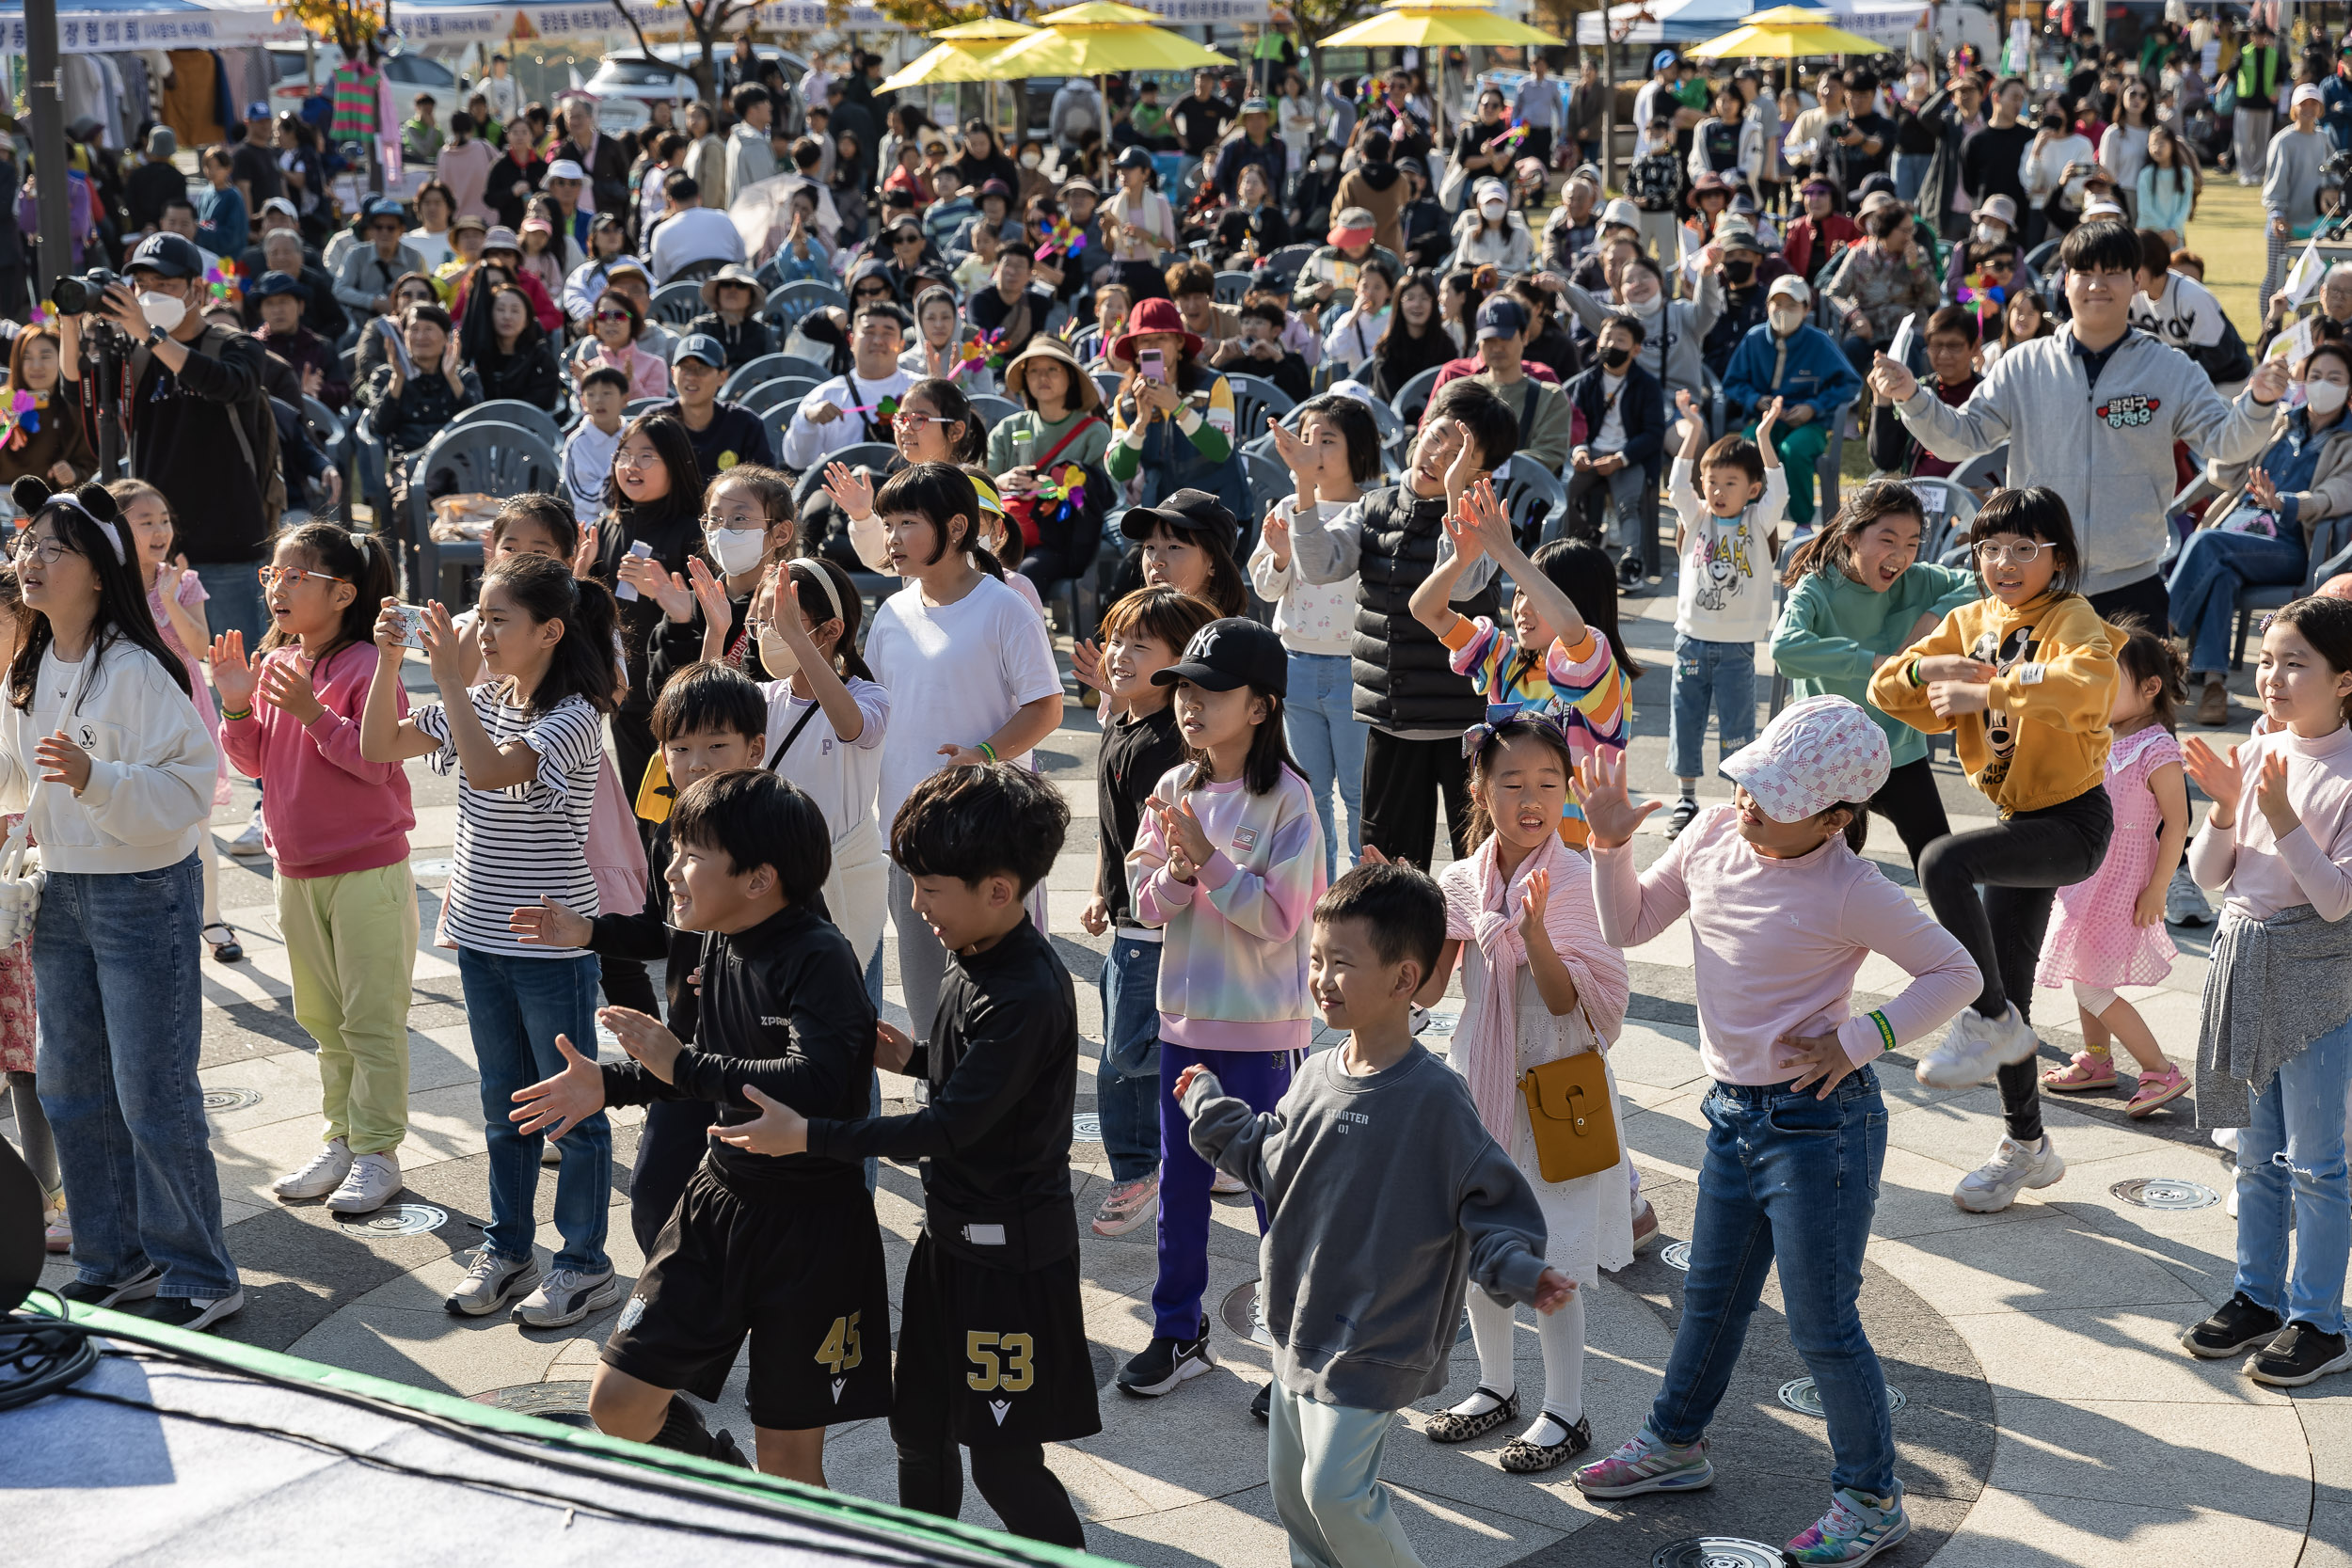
[212, 522, 417, 1213]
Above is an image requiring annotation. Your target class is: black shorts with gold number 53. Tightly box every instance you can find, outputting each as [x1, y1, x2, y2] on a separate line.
[889, 1232, 1104, 1449]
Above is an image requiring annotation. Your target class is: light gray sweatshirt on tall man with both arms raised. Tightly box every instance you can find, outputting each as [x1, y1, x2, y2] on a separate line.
[1899, 326, 2277, 594]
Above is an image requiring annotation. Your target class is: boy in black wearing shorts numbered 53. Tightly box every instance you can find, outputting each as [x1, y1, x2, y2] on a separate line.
[720, 762, 1104, 1547]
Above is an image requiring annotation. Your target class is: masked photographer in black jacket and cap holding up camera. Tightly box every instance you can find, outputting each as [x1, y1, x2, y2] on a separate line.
[55, 232, 285, 646]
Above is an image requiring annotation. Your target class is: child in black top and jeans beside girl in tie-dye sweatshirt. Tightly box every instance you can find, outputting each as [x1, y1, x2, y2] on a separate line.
[1077, 588, 1216, 1237]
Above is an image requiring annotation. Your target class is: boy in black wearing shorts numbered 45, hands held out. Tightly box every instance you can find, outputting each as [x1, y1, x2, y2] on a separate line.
[513, 768, 884, 1486]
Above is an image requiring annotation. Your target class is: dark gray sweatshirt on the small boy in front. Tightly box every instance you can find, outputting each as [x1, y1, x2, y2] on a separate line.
[1184, 1044, 1546, 1411]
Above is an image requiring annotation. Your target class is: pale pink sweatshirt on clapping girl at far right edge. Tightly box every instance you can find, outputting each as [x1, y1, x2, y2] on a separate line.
[2190, 726, 2352, 919]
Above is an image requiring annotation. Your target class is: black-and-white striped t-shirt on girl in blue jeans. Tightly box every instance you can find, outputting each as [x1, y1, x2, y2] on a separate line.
[409, 682, 605, 959]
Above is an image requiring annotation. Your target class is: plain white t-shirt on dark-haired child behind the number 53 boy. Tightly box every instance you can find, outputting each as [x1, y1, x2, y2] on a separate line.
[866, 576, 1061, 823]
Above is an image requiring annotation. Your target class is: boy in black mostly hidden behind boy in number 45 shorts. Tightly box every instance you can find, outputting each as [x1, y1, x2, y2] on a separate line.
[506, 665, 767, 1258]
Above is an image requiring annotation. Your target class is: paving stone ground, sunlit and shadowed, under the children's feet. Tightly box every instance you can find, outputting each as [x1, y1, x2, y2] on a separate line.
[8, 580, 2352, 1568]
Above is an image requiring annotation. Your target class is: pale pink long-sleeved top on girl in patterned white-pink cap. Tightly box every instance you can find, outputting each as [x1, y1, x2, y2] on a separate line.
[1593, 806, 1985, 1084]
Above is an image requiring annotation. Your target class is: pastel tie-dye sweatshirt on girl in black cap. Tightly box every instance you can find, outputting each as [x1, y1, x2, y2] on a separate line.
[1127, 762, 1325, 1051]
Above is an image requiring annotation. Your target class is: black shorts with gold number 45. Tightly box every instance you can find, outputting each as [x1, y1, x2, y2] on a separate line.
[602, 1162, 892, 1432]
